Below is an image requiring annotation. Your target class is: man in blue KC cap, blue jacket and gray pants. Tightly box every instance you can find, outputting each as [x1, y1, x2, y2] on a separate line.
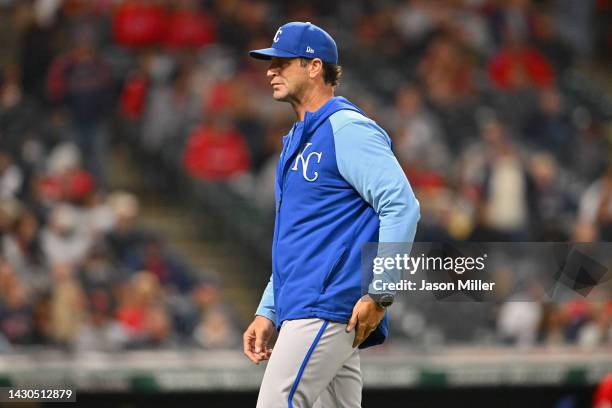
[243, 22, 419, 408]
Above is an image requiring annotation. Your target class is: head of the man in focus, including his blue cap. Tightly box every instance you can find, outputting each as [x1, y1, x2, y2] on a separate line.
[249, 22, 341, 101]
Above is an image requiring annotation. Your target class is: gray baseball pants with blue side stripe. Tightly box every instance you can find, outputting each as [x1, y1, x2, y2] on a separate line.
[257, 319, 362, 408]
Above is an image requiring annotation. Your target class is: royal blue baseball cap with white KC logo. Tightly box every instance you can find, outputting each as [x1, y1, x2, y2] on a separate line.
[249, 22, 338, 64]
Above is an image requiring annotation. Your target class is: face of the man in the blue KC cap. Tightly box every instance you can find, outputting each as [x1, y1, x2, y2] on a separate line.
[267, 57, 308, 101]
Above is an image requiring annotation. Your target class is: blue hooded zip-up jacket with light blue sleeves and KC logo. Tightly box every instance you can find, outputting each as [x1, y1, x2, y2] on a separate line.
[256, 97, 419, 348]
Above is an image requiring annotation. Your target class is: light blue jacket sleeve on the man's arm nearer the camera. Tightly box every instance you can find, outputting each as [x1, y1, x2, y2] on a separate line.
[330, 110, 420, 293]
